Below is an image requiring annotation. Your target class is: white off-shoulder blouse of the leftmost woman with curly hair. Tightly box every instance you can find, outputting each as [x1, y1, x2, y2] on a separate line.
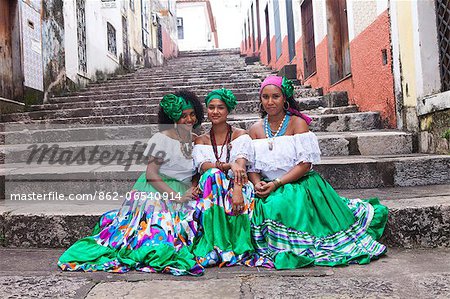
[144, 132, 195, 182]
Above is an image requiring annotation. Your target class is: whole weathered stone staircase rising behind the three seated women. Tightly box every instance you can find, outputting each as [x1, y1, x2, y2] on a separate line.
[0, 50, 450, 247]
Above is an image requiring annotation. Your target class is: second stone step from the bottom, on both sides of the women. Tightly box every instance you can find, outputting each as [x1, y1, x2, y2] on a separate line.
[0, 152, 450, 198]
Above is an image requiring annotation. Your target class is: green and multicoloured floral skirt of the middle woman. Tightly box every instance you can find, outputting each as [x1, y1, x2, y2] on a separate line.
[192, 168, 263, 267]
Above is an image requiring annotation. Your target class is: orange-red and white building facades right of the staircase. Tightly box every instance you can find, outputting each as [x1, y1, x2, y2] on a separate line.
[241, 0, 450, 151]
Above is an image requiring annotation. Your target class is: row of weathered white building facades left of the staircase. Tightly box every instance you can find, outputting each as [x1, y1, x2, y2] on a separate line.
[0, 0, 178, 104]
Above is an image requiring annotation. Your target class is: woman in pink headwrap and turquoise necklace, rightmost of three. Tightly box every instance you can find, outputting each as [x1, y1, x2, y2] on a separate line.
[249, 76, 387, 269]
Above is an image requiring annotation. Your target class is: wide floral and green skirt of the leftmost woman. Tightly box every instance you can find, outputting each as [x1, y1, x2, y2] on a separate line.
[58, 173, 204, 275]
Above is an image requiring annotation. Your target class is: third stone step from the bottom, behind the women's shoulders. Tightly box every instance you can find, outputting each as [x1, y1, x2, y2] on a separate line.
[0, 128, 413, 163]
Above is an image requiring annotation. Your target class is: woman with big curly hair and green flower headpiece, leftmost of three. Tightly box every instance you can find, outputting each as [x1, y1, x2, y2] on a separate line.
[58, 91, 207, 275]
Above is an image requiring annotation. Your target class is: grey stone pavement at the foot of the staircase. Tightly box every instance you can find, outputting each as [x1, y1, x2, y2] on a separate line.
[0, 248, 450, 298]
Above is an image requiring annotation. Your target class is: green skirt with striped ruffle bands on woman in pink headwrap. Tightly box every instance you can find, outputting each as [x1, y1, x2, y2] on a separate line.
[251, 171, 388, 269]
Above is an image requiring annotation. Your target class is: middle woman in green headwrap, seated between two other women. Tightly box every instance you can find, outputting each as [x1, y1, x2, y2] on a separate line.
[192, 89, 268, 267]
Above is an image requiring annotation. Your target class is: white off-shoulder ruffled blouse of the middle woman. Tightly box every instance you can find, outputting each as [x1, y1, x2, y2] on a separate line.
[192, 134, 253, 173]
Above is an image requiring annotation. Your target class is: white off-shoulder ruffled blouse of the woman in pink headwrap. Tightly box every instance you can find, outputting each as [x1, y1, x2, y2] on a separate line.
[249, 132, 320, 180]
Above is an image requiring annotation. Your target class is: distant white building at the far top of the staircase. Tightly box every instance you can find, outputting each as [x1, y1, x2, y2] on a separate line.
[177, 2, 214, 51]
